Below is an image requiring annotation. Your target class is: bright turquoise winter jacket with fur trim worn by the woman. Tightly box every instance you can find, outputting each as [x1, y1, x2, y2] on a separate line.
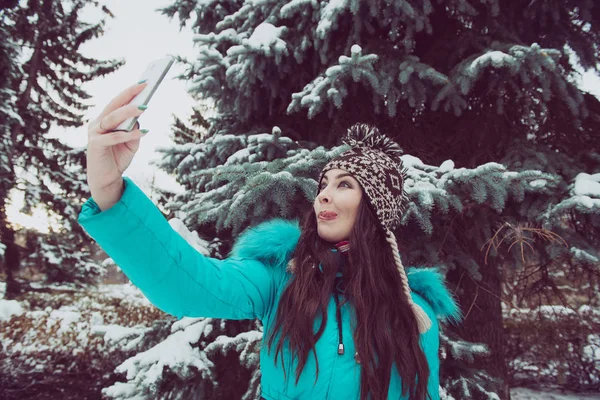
[79, 178, 460, 400]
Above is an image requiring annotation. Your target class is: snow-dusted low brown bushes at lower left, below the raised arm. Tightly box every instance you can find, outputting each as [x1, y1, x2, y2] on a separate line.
[0, 285, 162, 360]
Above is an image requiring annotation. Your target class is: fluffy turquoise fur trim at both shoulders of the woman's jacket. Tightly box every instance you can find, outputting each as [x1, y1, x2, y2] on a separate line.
[230, 219, 461, 322]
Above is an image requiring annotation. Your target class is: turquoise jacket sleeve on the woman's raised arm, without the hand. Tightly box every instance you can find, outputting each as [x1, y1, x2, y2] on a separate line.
[78, 178, 276, 320]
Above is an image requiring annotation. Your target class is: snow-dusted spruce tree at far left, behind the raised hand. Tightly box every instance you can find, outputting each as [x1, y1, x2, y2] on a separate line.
[0, 0, 123, 298]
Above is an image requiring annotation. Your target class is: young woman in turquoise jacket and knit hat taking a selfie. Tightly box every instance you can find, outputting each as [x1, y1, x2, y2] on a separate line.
[79, 84, 459, 400]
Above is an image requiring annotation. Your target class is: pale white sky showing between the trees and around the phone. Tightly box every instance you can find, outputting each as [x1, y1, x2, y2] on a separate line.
[7, 0, 600, 232]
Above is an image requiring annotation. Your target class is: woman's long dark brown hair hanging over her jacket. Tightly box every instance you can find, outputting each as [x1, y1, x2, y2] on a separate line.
[268, 197, 429, 400]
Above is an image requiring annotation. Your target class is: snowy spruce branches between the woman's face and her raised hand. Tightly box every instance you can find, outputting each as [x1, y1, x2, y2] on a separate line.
[158, 123, 341, 237]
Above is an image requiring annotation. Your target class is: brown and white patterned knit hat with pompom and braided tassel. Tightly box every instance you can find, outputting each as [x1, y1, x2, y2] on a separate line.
[318, 124, 431, 333]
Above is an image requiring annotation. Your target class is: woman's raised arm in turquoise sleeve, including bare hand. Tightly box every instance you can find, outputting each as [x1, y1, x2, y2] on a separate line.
[79, 81, 284, 319]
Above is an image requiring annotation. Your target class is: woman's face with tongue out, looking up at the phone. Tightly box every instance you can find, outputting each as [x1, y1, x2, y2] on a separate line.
[313, 169, 363, 243]
